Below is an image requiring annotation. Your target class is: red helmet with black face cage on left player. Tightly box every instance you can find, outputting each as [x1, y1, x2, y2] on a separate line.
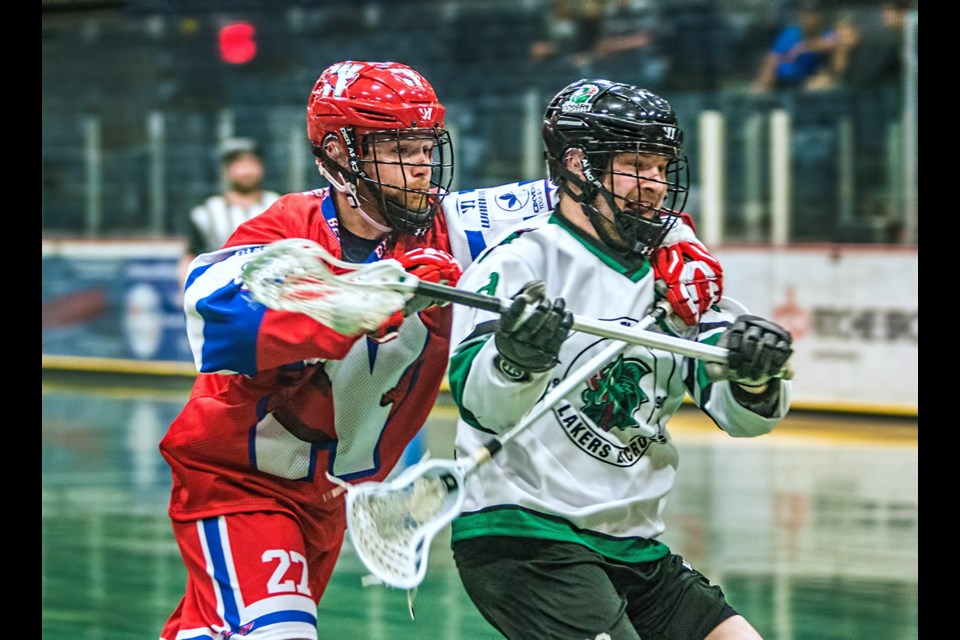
[307, 60, 453, 233]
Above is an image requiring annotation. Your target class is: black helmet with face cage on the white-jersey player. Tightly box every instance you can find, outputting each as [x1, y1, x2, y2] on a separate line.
[543, 79, 689, 257]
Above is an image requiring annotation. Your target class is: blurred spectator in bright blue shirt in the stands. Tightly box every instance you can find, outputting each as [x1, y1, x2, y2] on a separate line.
[753, 0, 836, 92]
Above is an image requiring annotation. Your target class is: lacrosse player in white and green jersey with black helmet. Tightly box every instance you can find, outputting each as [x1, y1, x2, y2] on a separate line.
[448, 79, 792, 640]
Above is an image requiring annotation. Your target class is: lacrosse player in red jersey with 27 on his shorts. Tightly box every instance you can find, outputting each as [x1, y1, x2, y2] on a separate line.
[160, 61, 721, 640]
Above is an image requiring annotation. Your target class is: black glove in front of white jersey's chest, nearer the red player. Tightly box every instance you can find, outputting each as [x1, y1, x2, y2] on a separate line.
[494, 280, 573, 380]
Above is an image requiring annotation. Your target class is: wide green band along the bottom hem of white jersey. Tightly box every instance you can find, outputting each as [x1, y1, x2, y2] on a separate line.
[451, 507, 670, 562]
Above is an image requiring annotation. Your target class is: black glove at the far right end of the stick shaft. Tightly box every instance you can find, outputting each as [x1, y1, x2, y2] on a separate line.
[719, 315, 793, 387]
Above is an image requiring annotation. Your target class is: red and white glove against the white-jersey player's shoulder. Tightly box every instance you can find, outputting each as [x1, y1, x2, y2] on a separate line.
[653, 242, 723, 326]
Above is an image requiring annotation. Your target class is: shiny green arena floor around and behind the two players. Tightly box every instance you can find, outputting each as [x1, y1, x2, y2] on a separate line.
[41, 380, 919, 640]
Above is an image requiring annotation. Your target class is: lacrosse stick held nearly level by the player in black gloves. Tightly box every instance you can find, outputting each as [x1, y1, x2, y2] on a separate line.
[242, 238, 727, 365]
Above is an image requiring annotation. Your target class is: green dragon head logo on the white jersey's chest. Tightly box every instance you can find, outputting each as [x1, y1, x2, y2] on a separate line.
[580, 356, 650, 431]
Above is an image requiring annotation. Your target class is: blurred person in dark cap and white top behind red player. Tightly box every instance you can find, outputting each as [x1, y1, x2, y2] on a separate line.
[180, 138, 280, 280]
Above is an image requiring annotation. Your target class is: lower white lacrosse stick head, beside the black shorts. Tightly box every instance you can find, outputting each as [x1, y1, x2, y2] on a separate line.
[346, 460, 466, 590]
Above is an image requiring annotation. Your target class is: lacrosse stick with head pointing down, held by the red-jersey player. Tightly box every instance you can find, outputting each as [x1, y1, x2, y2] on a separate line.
[343, 302, 670, 592]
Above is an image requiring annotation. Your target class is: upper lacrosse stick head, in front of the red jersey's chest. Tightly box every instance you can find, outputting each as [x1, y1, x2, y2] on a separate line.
[241, 238, 416, 336]
